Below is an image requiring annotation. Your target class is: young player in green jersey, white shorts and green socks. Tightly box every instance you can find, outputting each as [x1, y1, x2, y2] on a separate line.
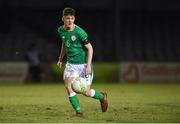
[57, 8, 108, 115]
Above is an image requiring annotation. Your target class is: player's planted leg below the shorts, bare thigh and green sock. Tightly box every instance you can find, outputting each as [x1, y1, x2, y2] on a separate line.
[65, 78, 81, 115]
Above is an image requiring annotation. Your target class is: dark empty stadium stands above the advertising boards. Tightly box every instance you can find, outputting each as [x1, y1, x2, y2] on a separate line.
[0, 0, 180, 83]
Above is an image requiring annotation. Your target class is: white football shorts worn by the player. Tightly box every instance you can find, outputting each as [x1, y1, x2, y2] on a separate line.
[63, 63, 94, 85]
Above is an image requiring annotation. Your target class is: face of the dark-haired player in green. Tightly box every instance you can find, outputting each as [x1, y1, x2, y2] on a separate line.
[62, 15, 75, 30]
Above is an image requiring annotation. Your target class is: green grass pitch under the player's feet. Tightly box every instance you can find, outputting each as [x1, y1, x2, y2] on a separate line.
[0, 84, 180, 123]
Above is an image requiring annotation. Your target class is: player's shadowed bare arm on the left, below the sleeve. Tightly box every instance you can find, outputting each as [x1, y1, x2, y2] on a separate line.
[57, 42, 66, 68]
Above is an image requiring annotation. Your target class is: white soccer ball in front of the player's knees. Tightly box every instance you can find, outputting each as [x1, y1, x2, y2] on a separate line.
[72, 77, 87, 93]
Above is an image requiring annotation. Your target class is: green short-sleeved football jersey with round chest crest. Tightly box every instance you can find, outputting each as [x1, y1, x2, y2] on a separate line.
[58, 25, 88, 64]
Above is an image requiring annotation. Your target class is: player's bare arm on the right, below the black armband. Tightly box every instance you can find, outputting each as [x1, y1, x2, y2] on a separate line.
[84, 42, 93, 75]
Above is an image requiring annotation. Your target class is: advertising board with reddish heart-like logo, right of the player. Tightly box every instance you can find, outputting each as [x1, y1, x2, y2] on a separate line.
[119, 62, 180, 82]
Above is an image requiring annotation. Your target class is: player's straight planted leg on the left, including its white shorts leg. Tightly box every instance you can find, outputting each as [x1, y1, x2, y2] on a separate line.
[64, 64, 81, 114]
